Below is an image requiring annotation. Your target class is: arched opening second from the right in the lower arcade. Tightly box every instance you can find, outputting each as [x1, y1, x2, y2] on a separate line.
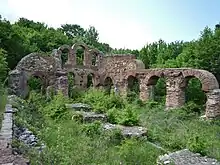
[147, 76, 166, 103]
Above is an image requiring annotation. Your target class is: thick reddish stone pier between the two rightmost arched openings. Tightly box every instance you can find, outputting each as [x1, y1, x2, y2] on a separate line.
[166, 76, 185, 110]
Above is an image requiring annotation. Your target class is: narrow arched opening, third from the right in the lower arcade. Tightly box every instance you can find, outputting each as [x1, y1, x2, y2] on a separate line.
[127, 76, 140, 101]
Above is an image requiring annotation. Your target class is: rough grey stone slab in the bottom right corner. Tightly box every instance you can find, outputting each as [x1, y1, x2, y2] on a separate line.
[157, 149, 220, 165]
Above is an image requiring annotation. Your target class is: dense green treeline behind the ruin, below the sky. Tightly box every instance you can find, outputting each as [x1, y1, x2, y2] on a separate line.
[0, 17, 220, 103]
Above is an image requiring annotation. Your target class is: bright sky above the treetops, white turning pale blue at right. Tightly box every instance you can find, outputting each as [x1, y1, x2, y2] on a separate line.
[0, 0, 220, 49]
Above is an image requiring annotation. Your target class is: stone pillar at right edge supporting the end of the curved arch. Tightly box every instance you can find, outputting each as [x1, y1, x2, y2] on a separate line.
[205, 89, 220, 119]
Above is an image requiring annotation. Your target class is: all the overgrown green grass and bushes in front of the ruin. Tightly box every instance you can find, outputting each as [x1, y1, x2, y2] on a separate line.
[13, 89, 220, 165]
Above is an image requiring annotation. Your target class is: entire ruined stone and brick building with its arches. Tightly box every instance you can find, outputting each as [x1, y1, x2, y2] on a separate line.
[9, 43, 220, 119]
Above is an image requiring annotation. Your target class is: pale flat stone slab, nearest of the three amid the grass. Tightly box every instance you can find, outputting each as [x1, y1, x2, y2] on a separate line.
[103, 123, 147, 137]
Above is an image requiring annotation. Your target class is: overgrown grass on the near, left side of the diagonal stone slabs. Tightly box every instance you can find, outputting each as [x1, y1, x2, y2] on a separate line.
[15, 91, 163, 165]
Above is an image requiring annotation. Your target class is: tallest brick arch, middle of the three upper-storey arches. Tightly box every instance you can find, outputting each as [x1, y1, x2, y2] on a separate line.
[71, 43, 89, 66]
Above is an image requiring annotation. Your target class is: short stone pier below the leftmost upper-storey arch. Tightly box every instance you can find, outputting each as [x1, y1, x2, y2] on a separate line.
[57, 76, 68, 97]
